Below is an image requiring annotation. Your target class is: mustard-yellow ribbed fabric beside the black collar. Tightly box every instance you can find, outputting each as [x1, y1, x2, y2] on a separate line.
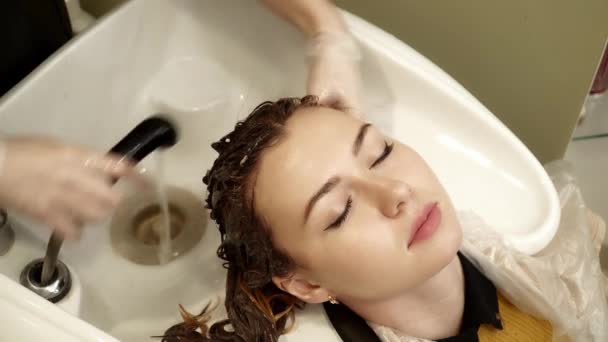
[477, 292, 552, 342]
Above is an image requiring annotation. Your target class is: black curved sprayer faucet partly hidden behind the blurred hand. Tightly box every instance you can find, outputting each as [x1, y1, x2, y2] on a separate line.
[32, 116, 178, 294]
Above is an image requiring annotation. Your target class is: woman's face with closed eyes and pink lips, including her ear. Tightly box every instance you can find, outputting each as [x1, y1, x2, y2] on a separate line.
[253, 107, 462, 302]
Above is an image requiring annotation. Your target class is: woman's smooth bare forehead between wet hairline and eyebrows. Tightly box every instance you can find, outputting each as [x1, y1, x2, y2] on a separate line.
[254, 107, 362, 226]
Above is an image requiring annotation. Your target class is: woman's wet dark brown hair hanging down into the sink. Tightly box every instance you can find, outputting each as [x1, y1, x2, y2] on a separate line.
[162, 96, 319, 342]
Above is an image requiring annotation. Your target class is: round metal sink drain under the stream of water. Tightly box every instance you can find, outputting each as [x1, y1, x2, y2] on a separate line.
[110, 186, 207, 265]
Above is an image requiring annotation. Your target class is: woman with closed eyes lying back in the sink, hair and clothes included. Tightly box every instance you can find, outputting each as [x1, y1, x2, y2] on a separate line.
[164, 96, 606, 341]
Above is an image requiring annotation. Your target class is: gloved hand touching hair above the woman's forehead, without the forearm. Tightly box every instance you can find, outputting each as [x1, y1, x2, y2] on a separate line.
[307, 32, 362, 116]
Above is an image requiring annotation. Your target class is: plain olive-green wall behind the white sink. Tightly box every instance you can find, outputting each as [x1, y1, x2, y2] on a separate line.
[81, 0, 608, 162]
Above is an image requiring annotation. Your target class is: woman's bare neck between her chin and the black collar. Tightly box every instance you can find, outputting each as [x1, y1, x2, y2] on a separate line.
[345, 256, 464, 340]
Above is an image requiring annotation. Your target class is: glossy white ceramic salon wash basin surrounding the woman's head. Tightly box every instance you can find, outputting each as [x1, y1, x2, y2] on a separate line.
[0, 0, 559, 341]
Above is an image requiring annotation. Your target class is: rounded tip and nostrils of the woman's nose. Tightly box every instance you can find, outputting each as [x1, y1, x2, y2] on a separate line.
[368, 176, 412, 217]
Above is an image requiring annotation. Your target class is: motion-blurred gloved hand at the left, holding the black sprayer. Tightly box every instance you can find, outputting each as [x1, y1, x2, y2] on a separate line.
[0, 137, 145, 239]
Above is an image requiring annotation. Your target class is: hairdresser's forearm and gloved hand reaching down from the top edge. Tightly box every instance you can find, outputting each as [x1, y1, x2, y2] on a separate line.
[261, 0, 361, 114]
